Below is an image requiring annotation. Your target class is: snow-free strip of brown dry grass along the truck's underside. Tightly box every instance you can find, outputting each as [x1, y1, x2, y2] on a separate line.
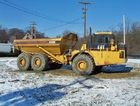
[18, 69, 140, 79]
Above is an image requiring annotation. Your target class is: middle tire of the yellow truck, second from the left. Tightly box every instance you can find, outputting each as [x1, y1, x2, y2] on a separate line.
[31, 53, 48, 71]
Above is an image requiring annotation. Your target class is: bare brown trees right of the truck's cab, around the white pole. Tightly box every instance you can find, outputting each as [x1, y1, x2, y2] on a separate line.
[111, 20, 140, 55]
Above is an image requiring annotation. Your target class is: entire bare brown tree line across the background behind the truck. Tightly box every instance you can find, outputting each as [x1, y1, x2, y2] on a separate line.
[0, 20, 140, 55]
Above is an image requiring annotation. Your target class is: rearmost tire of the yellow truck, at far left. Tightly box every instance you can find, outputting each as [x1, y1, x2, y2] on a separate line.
[17, 53, 31, 71]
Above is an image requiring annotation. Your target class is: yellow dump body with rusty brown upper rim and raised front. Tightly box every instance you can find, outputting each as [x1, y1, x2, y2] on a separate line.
[13, 33, 78, 55]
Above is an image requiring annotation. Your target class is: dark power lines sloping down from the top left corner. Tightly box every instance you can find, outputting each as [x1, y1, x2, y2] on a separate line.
[0, 0, 79, 23]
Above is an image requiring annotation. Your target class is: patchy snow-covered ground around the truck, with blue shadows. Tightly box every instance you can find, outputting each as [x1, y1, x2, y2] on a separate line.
[0, 58, 140, 106]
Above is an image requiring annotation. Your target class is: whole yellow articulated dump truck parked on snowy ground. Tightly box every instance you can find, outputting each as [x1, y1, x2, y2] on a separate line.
[13, 32, 127, 75]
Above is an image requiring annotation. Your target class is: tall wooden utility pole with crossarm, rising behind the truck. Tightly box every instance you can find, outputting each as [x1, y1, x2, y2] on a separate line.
[79, 2, 91, 43]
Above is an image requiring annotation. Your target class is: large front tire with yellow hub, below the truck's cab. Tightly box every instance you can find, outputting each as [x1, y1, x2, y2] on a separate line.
[72, 54, 95, 75]
